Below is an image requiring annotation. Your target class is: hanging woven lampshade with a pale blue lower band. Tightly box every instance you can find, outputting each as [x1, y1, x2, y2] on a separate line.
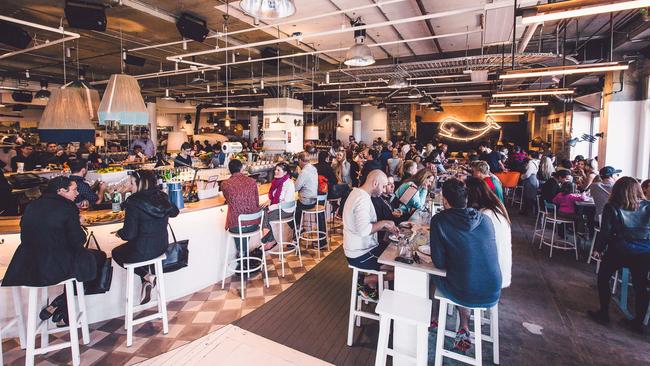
[98, 74, 149, 126]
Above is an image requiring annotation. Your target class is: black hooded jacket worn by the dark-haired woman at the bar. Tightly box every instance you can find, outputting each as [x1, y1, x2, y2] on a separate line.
[113, 189, 179, 264]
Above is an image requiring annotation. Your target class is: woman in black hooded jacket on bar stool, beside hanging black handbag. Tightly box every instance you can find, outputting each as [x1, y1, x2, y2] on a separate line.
[112, 171, 178, 304]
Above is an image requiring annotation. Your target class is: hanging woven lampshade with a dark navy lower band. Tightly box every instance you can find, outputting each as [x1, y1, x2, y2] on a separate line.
[38, 88, 95, 143]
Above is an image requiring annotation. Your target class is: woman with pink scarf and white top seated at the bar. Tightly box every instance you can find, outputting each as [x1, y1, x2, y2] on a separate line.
[262, 162, 296, 250]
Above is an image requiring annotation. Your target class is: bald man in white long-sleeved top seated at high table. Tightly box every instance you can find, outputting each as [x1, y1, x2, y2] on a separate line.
[343, 170, 399, 299]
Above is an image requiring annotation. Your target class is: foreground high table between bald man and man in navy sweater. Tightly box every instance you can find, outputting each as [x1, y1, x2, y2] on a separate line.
[378, 239, 447, 365]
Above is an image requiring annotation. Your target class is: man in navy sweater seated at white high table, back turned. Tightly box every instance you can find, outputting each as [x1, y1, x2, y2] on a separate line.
[429, 178, 501, 352]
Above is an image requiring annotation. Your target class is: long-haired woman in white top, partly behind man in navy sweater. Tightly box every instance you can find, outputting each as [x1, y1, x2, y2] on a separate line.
[465, 177, 512, 288]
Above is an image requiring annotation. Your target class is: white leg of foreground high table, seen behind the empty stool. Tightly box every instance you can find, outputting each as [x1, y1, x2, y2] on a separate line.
[393, 267, 429, 366]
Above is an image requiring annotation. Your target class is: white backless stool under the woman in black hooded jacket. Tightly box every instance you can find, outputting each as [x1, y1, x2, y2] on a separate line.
[124, 254, 169, 347]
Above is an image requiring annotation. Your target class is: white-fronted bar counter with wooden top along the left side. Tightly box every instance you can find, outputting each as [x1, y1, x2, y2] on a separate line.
[0, 184, 271, 336]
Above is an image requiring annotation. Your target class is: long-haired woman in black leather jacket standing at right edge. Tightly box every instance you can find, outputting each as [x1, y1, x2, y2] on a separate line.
[588, 177, 650, 333]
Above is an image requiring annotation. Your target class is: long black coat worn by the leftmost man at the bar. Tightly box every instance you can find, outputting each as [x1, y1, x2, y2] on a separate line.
[2, 193, 97, 287]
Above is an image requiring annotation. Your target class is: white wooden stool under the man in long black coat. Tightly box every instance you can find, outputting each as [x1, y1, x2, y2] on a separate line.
[24, 279, 90, 366]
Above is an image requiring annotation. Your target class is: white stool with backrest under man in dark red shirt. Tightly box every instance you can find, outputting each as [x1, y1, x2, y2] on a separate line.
[221, 210, 269, 300]
